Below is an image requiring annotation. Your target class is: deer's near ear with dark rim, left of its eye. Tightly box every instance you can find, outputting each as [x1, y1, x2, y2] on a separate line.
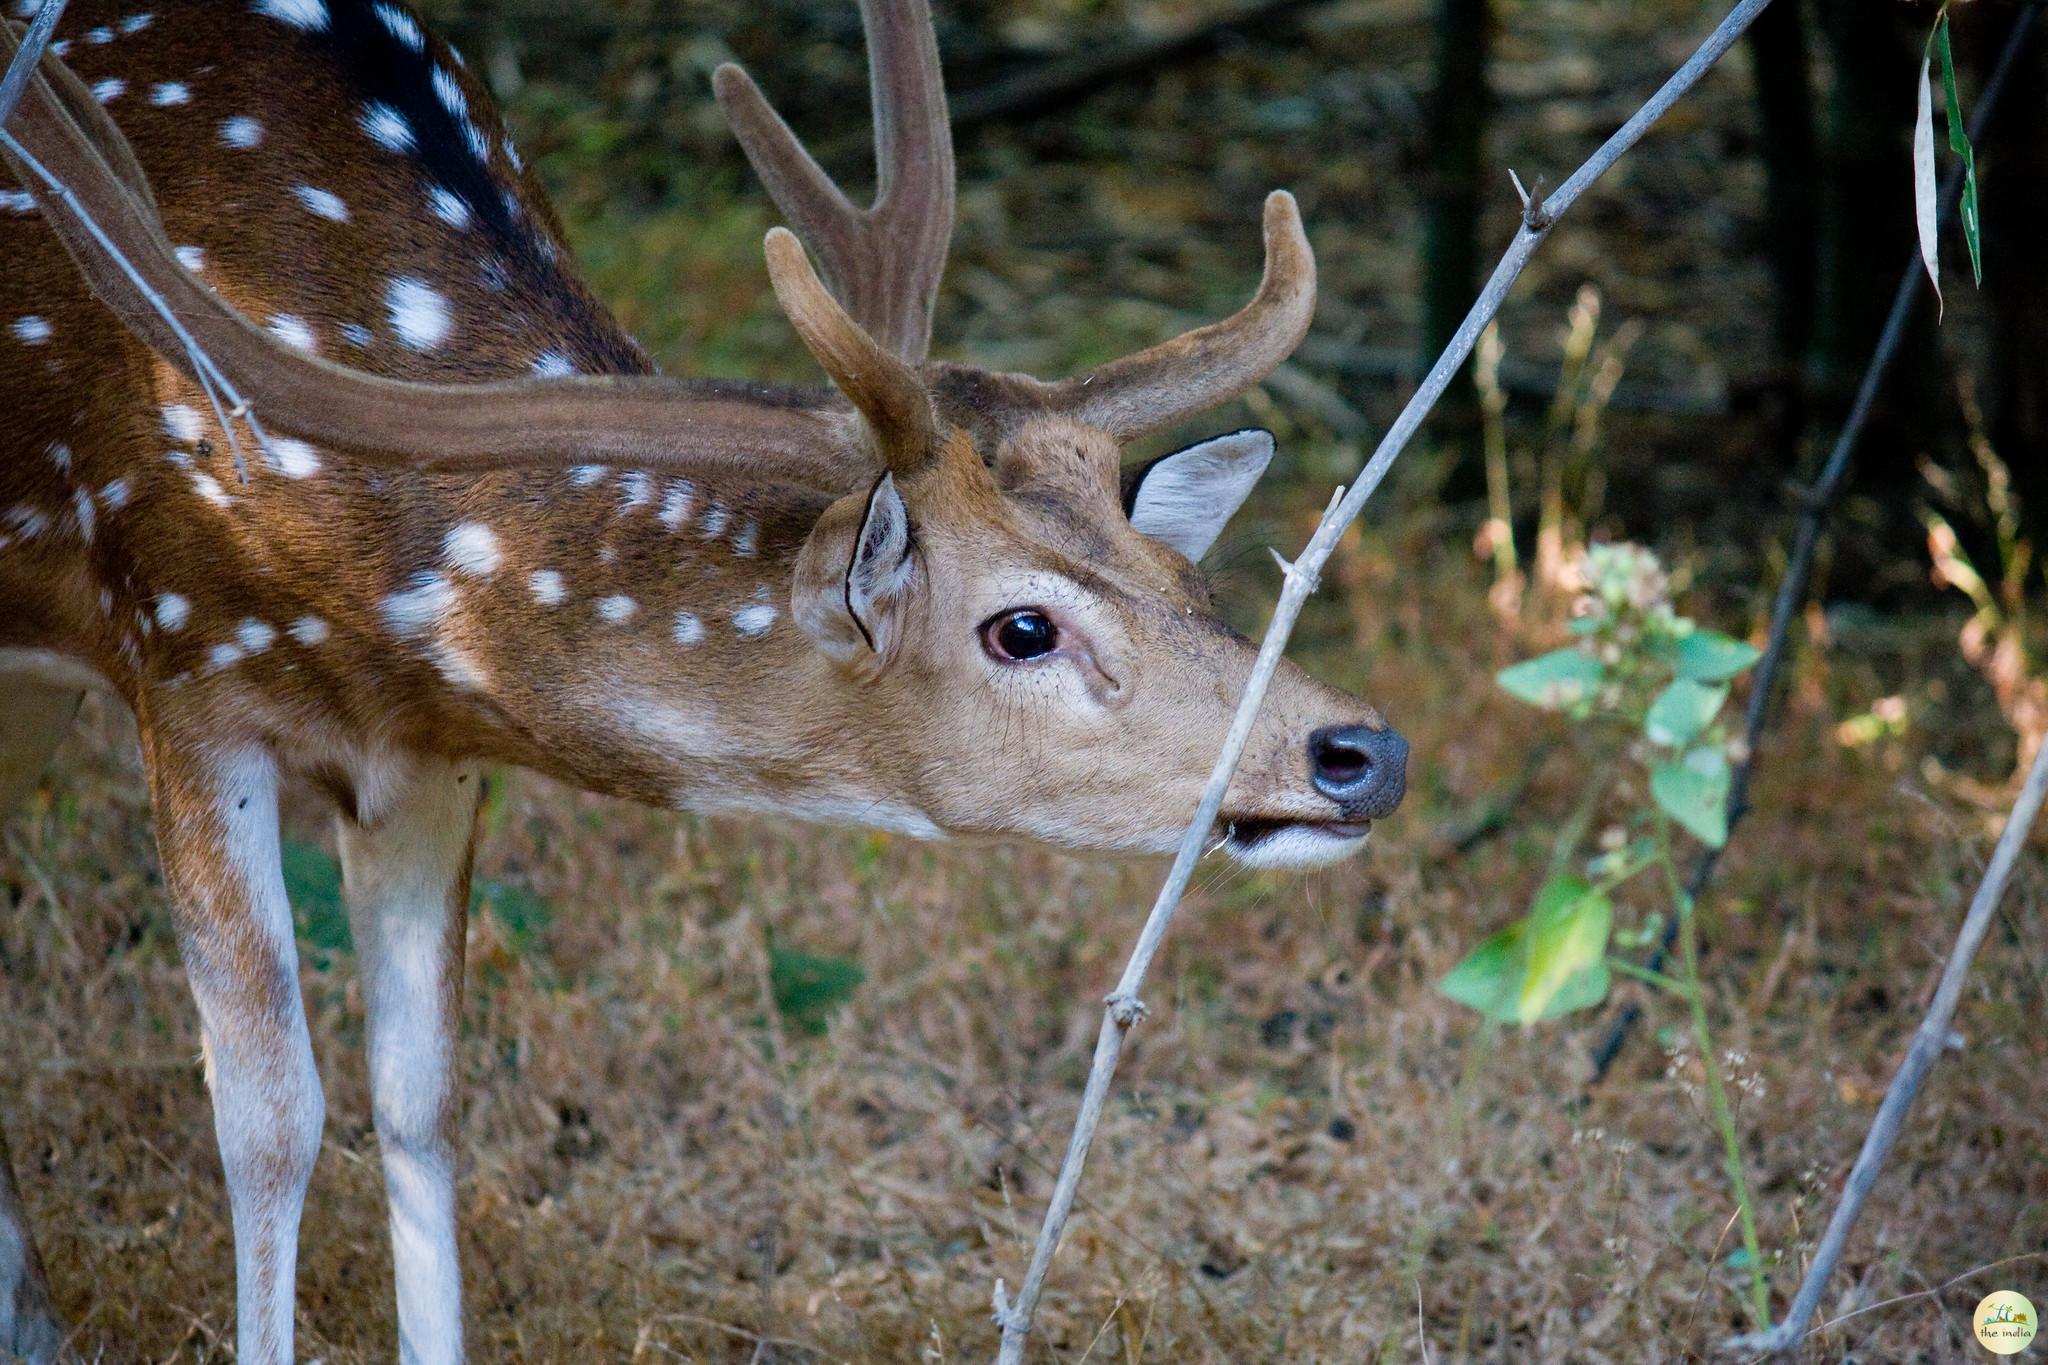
[793, 475, 918, 663]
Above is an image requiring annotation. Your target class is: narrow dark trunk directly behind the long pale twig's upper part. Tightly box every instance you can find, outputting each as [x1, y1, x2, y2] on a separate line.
[1421, 0, 1493, 497]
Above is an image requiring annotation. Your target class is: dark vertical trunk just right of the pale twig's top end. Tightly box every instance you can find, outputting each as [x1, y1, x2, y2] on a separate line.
[1749, 0, 1821, 469]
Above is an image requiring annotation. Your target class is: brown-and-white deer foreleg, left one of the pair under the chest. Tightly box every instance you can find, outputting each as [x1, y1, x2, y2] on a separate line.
[143, 733, 326, 1365]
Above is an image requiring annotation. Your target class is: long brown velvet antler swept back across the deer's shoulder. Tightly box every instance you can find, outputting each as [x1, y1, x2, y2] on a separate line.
[0, 25, 850, 489]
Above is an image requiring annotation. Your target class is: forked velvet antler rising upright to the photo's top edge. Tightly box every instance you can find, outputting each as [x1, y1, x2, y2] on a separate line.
[713, 0, 952, 364]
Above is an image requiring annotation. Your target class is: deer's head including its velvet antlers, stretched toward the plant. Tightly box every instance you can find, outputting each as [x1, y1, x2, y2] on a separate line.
[0, 0, 1407, 864]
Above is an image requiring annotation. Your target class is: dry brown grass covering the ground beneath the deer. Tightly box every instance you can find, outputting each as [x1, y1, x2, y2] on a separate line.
[0, 517, 2048, 1365]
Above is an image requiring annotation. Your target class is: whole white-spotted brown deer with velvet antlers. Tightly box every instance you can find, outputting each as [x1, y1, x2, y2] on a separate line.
[0, 0, 1407, 1365]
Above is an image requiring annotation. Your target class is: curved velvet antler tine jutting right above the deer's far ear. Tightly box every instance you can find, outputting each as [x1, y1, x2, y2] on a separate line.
[1044, 190, 1315, 440]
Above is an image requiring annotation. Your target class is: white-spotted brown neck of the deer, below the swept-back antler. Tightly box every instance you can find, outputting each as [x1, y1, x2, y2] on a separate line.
[344, 465, 897, 808]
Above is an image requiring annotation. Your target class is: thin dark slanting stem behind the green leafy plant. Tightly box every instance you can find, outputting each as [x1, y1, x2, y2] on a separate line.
[1587, 4, 2038, 1085]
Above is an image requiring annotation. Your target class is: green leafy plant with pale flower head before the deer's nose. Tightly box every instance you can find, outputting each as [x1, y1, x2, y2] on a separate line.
[1438, 544, 1769, 1326]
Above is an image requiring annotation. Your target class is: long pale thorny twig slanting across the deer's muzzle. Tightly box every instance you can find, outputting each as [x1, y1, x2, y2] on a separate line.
[993, 0, 1769, 1365]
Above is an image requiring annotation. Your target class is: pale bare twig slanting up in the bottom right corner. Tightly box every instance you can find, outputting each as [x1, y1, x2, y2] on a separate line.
[1729, 745, 2048, 1355]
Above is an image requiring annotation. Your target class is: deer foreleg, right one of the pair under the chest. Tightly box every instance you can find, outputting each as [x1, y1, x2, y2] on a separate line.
[340, 763, 483, 1365]
